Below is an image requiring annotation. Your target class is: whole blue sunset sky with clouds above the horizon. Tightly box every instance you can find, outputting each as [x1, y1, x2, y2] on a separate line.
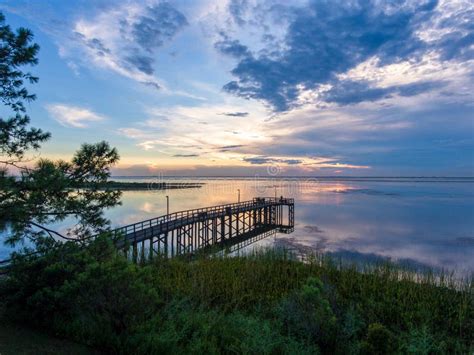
[0, 0, 474, 176]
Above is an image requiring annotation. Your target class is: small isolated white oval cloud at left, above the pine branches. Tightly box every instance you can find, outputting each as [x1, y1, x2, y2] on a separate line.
[46, 104, 106, 128]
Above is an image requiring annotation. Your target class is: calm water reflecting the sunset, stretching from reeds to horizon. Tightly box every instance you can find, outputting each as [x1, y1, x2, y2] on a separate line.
[0, 178, 474, 271]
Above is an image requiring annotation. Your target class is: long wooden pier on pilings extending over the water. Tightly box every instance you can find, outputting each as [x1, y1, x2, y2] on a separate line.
[112, 197, 294, 262]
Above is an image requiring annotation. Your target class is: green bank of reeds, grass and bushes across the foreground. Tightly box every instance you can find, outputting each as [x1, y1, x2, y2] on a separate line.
[0, 240, 474, 354]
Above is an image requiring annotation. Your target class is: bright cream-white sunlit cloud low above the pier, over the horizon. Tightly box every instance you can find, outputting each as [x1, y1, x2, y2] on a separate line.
[115, 101, 374, 173]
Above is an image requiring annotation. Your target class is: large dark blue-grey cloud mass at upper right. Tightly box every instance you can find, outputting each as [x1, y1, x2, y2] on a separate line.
[220, 0, 474, 111]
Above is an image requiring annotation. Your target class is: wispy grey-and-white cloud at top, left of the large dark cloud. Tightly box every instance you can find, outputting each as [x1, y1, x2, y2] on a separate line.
[66, 2, 188, 89]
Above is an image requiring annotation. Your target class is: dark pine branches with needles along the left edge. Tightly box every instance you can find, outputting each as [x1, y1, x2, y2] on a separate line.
[0, 13, 120, 250]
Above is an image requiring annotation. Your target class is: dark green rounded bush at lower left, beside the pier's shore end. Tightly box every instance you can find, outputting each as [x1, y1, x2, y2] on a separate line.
[0, 239, 162, 350]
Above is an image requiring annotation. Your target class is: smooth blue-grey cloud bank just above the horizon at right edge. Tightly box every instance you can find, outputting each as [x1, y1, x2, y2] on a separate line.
[262, 100, 474, 176]
